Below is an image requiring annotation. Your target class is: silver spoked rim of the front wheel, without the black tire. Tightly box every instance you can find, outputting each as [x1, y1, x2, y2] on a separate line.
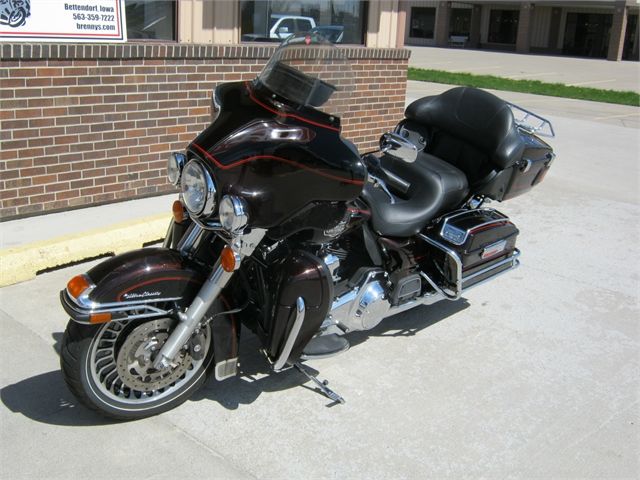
[87, 318, 211, 407]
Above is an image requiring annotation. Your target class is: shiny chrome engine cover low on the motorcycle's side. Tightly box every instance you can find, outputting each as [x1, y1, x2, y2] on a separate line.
[330, 269, 391, 332]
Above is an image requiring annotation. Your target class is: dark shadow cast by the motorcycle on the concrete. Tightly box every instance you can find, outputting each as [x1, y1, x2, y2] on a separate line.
[0, 299, 469, 427]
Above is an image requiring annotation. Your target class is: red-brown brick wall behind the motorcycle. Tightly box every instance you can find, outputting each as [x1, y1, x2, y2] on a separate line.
[0, 44, 409, 220]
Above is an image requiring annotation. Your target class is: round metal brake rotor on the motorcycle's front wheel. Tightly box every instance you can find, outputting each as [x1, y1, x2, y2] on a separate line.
[116, 318, 192, 393]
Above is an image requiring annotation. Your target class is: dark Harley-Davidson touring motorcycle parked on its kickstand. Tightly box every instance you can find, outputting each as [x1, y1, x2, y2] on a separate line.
[60, 35, 554, 419]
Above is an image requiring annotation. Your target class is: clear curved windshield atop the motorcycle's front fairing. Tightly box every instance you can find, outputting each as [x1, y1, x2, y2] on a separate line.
[256, 32, 355, 116]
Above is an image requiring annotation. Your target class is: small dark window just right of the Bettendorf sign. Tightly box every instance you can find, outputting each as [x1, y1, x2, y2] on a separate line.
[125, 0, 176, 40]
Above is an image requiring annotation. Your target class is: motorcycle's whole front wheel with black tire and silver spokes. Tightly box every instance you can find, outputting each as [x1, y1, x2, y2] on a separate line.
[60, 318, 213, 420]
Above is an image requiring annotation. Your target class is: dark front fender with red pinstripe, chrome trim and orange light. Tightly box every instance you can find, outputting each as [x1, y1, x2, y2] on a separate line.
[60, 248, 240, 380]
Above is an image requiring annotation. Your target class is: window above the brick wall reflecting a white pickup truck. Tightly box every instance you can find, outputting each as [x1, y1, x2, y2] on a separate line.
[240, 0, 367, 44]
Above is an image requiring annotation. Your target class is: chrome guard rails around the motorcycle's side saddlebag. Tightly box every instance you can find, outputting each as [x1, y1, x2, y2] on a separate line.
[418, 233, 520, 300]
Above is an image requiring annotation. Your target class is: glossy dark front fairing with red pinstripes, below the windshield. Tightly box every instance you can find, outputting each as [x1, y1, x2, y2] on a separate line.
[187, 82, 366, 236]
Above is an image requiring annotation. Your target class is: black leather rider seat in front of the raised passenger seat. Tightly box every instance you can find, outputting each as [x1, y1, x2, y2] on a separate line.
[363, 152, 469, 237]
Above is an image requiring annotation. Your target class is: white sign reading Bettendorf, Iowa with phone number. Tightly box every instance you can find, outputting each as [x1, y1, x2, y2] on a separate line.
[0, 0, 127, 43]
